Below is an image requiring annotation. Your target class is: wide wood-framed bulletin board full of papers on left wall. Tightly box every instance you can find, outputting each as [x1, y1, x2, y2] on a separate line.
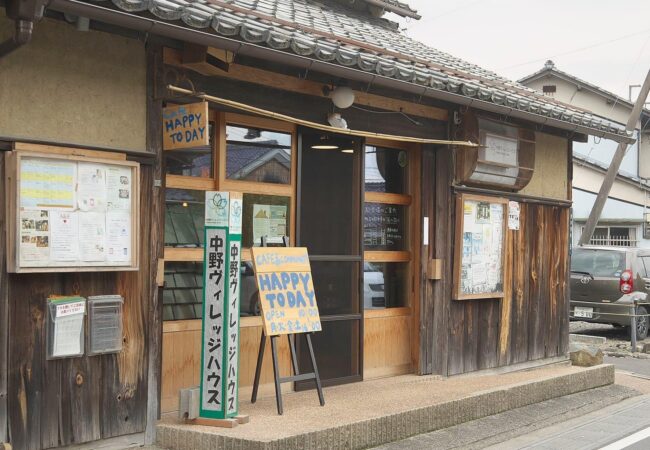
[5, 148, 140, 273]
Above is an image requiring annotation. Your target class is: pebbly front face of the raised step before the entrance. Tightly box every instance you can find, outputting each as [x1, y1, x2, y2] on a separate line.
[156, 364, 615, 450]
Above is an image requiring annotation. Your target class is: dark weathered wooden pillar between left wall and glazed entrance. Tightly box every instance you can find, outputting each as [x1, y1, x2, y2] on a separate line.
[142, 41, 165, 444]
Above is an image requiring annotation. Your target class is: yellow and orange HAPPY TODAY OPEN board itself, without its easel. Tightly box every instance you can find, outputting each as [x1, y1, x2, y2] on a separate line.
[251, 247, 321, 336]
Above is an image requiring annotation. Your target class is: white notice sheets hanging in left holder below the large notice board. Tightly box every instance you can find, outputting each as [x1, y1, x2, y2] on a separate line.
[52, 301, 86, 357]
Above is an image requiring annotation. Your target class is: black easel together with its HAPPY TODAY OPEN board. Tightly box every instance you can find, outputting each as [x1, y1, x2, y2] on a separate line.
[251, 236, 325, 415]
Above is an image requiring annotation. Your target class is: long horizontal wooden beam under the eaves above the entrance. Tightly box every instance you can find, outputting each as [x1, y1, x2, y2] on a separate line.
[163, 48, 447, 121]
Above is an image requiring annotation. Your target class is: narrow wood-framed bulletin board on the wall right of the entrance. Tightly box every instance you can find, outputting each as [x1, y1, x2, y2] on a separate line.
[454, 194, 508, 300]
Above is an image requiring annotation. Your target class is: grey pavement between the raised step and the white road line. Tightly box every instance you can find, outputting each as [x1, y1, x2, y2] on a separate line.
[378, 385, 650, 450]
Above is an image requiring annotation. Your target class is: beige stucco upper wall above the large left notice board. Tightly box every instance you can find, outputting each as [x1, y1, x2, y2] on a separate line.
[0, 9, 146, 151]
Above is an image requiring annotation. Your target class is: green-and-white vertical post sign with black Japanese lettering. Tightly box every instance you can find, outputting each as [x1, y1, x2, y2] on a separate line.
[199, 192, 242, 419]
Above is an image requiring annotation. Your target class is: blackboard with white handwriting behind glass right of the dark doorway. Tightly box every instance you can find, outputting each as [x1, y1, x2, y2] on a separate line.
[363, 203, 405, 250]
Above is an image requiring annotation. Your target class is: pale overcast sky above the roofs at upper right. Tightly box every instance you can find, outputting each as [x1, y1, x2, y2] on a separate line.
[390, 0, 650, 98]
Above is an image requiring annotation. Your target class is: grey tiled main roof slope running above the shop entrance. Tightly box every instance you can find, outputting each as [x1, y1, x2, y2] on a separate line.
[86, 0, 627, 137]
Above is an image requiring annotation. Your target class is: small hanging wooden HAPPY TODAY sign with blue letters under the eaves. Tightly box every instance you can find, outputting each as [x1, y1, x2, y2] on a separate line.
[163, 102, 210, 150]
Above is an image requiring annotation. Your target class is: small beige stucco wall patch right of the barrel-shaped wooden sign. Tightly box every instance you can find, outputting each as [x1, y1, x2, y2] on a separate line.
[520, 132, 568, 200]
